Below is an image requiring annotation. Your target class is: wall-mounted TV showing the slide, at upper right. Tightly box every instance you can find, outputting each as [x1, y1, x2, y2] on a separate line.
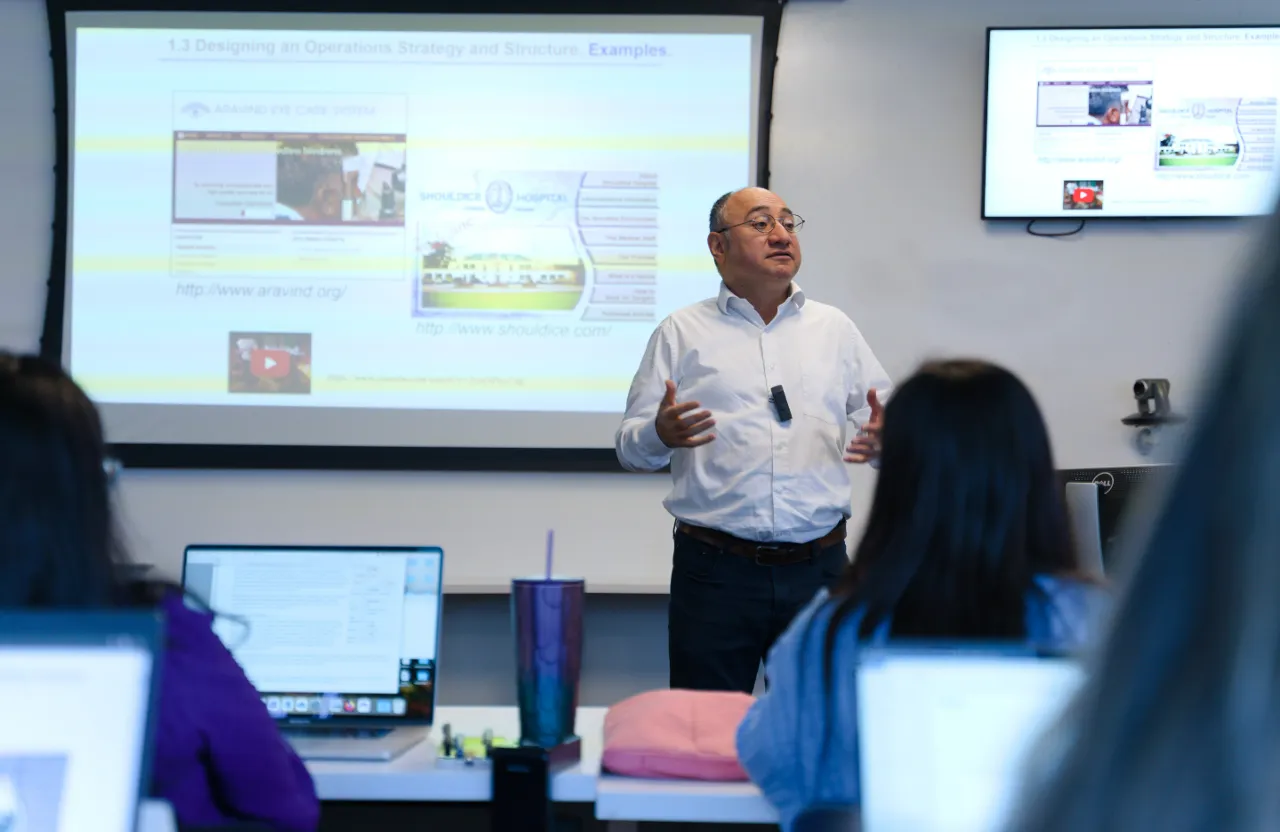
[982, 27, 1280, 219]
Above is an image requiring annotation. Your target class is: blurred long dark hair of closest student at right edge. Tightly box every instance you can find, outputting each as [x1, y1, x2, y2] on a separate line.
[1012, 207, 1280, 832]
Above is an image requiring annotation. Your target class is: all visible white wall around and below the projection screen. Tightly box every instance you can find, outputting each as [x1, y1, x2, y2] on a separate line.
[0, 0, 1280, 703]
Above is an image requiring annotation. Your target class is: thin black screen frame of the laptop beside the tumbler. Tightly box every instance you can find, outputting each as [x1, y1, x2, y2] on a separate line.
[178, 543, 444, 730]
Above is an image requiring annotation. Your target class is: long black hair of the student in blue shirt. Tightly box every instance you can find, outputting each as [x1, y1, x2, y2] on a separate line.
[823, 361, 1076, 680]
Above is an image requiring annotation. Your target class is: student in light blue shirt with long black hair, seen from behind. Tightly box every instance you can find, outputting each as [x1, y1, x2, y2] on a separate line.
[737, 361, 1102, 829]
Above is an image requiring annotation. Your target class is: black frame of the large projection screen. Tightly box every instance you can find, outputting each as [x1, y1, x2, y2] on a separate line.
[40, 0, 787, 474]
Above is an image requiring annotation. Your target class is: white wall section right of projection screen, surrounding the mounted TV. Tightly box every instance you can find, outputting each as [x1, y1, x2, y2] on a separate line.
[771, 0, 1264, 467]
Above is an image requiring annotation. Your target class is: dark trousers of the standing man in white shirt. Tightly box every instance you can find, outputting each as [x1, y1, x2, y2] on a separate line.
[667, 531, 849, 694]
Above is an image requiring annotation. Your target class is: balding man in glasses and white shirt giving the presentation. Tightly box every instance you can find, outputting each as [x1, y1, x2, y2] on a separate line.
[616, 188, 890, 692]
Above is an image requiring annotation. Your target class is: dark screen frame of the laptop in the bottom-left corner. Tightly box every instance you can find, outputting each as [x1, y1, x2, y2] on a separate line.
[0, 611, 165, 822]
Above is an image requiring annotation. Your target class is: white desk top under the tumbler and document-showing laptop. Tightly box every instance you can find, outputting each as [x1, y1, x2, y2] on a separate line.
[307, 708, 605, 803]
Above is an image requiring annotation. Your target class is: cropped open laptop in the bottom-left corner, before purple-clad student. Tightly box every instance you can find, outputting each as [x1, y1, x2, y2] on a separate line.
[0, 612, 163, 832]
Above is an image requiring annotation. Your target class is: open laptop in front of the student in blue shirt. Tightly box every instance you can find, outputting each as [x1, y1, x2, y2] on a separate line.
[858, 645, 1083, 832]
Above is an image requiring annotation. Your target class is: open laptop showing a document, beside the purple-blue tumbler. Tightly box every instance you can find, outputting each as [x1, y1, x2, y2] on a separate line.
[183, 545, 444, 760]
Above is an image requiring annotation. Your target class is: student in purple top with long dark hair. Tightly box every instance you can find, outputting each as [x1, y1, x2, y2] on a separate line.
[0, 353, 320, 832]
